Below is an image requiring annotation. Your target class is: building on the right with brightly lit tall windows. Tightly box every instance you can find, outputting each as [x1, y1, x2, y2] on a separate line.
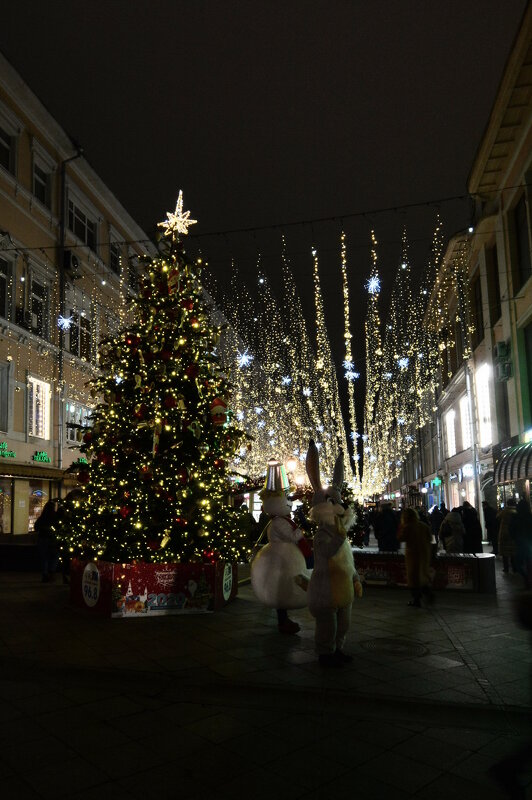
[384, 7, 532, 511]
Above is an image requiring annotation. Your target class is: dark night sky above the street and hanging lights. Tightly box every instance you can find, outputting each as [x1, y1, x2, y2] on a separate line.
[0, 0, 526, 378]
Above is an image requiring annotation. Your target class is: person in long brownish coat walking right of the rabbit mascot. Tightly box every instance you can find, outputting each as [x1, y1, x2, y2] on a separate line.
[397, 508, 434, 608]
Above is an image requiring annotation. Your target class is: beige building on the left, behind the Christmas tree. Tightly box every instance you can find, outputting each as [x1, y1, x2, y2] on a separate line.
[0, 55, 154, 534]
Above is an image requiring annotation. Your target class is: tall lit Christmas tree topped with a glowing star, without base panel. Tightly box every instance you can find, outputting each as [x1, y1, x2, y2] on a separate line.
[62, 192, 248, 562]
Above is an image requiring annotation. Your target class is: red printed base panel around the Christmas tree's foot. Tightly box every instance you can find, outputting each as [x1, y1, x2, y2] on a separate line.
[70, 559, 238, 619]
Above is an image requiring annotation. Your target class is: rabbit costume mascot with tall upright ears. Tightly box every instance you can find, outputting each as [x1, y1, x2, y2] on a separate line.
[306, 439, 362, 667]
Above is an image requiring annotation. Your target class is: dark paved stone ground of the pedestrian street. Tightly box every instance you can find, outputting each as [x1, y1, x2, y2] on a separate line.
[0, 564, 532, 800]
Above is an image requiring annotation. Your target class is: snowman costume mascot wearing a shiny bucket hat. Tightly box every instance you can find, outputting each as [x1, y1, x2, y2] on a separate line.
[251, 459, 308, 634]
